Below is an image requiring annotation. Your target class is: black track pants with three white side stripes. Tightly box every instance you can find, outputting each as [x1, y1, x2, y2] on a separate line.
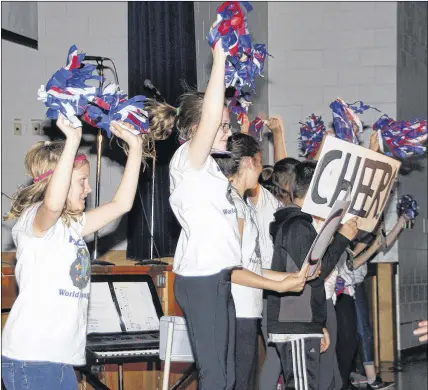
[276, 338, 320, 390]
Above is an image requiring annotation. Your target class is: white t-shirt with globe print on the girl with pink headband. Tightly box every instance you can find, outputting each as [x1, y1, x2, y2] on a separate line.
[2, 203, 91, 366]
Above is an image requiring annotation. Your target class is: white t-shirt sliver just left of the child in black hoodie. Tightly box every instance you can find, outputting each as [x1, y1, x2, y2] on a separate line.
[249, 185, 282, 269]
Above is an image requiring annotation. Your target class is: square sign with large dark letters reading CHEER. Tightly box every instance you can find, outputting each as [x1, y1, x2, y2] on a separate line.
[302, 136, 401, 232]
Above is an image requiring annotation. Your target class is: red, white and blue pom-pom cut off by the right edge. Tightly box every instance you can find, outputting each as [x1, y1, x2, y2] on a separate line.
[373, 114, 427, 160]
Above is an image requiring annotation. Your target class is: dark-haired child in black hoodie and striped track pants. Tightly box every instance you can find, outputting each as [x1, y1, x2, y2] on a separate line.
[267, 161, 358, 390]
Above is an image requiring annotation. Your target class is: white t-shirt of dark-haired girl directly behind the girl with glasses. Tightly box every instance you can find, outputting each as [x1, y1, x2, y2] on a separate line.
[232, 189, 263, 318]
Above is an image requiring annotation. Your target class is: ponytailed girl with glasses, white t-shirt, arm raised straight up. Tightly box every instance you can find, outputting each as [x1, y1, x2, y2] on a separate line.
[147, 41, 305, 390]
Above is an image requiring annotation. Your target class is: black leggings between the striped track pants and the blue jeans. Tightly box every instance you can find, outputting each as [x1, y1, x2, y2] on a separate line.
[336, 294, 358, 390]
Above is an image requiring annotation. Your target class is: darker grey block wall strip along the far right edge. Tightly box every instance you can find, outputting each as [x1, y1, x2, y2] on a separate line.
[397, 2, 428, 349]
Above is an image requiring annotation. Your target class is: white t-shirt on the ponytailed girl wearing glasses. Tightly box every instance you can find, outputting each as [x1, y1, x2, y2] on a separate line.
[169, 142, 241, 276]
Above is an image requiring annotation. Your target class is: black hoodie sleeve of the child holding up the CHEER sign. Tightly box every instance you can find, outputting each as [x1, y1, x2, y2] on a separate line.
[283, 218, 349, 287]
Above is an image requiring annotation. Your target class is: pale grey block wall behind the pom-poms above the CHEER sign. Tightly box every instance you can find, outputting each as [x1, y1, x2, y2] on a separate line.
[268, 1, 398, 261]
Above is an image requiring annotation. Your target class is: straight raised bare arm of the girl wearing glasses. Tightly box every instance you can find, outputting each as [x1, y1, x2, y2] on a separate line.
[189, 40, 227, 169]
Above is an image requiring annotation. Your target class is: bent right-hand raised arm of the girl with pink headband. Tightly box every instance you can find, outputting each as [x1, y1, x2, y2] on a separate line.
[82, 122, 143, 236]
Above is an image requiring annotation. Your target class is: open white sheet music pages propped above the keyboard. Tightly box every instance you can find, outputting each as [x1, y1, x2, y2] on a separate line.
[87, 281, 159, 334]
